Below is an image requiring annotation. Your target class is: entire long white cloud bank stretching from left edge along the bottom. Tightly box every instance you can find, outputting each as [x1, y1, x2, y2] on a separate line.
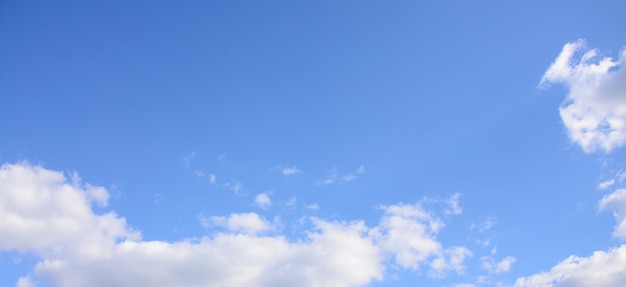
[0, 163, 471, 287]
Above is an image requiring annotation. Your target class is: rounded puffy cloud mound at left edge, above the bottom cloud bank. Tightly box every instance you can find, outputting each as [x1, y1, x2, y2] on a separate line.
[0, 163, 139, 256]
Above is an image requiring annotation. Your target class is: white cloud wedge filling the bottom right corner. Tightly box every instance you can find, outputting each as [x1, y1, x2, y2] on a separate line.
[515, 245, 626, 287]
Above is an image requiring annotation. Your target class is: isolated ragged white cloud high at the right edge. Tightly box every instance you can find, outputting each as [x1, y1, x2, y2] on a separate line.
[540, 40, 626, 153]
